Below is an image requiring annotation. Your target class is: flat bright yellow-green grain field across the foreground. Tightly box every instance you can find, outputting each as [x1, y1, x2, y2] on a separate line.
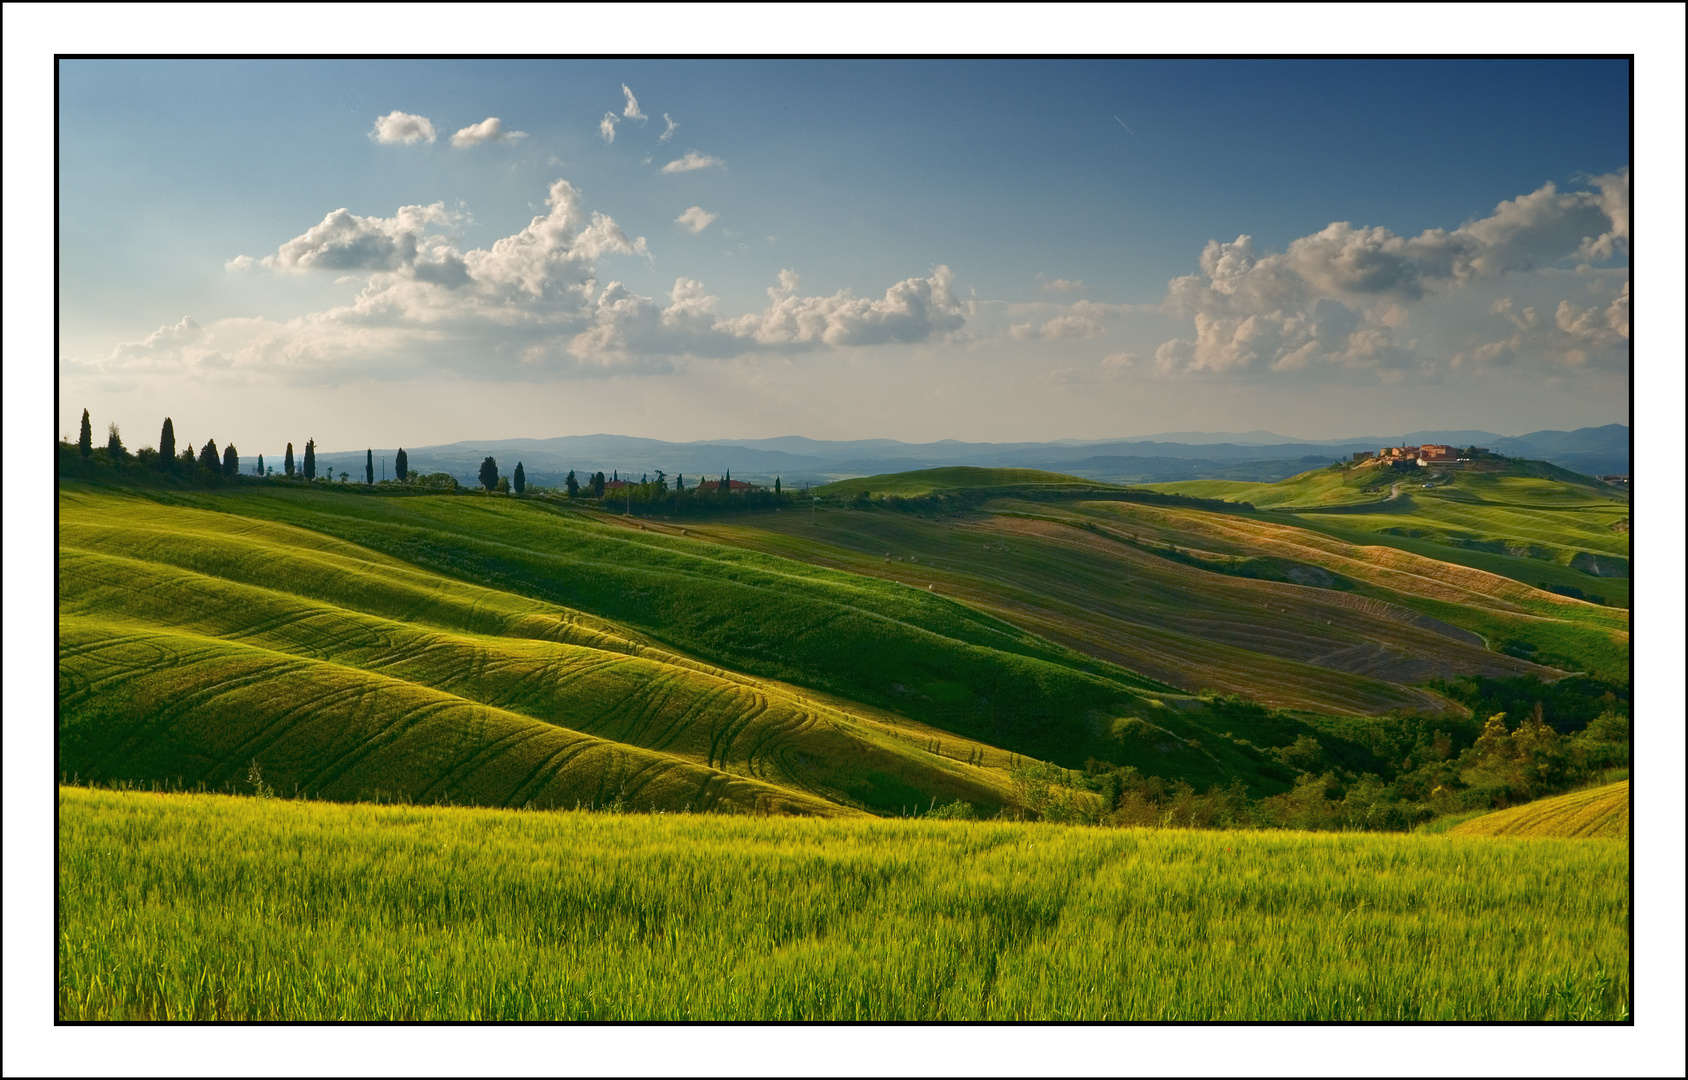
[57, 788, 1631, 1021]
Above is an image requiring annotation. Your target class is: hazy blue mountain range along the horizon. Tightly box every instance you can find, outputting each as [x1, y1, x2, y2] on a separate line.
[300, 424, 1629, 486]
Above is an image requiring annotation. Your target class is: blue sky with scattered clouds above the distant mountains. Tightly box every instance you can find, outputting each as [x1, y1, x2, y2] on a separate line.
[57, 59, 1631, 447]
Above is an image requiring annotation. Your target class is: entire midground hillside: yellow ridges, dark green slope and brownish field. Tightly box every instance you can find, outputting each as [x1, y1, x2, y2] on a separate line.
[59, 455, 1629, 813]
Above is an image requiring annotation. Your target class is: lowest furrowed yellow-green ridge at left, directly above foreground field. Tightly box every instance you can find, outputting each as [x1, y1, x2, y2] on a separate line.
[62, 618, 841, 813]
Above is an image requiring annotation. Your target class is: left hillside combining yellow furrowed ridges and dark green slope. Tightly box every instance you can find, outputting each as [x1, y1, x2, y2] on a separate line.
[59, 484, 1316, 813]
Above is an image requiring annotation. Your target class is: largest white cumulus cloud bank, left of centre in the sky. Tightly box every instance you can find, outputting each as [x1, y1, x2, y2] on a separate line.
[115, 179, 967, 385]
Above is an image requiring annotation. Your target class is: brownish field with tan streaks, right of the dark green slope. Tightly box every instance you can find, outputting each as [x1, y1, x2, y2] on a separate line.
[658, 500, 1606, 714]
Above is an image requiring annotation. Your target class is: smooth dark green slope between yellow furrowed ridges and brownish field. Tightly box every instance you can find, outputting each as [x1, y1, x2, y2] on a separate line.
[75, 488, 1316, 789]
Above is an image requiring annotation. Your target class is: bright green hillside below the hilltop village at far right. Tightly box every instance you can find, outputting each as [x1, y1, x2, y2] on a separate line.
[1150, 461, 1631, 590]
